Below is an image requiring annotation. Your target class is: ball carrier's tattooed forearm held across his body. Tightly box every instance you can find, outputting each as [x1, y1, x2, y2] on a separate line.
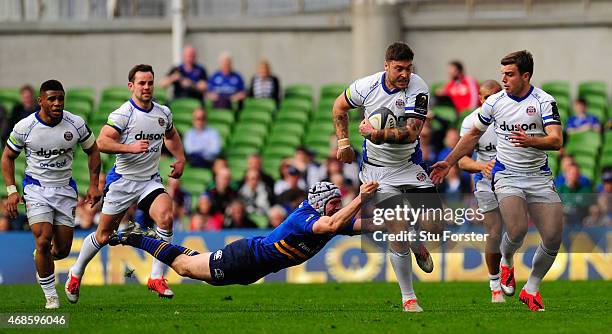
[359, 118, 425, 145]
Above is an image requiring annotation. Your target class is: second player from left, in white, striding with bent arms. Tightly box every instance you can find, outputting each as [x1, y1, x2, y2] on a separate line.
[65, 64, 185, 303]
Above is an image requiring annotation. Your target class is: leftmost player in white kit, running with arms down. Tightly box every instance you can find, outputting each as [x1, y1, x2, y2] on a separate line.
[2, 80, 102, 309]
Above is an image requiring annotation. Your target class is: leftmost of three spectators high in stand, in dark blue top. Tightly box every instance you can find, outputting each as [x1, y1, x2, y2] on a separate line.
[161, 45, 208, 102]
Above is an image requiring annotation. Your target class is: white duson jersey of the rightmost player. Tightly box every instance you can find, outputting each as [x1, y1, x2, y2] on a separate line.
[474, 86, 561, 173]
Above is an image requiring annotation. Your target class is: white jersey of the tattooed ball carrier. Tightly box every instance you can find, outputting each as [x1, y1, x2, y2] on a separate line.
[344, 71, 429, 166]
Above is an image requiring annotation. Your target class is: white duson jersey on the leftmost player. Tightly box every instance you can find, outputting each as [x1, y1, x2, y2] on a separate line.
[7, 110, 95, 187]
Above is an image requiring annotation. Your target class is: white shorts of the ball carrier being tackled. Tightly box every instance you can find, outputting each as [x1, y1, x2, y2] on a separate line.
[359, 163, 434, 195]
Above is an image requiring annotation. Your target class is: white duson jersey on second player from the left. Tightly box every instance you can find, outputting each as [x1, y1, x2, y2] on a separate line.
[107, 99, 173, 181]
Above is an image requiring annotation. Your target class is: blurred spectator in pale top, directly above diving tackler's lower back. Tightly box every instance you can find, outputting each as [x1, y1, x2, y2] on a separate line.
[238, 169, 273, 215]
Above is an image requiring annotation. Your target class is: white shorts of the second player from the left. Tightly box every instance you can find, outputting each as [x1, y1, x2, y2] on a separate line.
[102, 174, 164, 215]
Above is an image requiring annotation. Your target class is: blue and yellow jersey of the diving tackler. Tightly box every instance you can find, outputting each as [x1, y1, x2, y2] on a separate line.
[247, 201, 355, 272]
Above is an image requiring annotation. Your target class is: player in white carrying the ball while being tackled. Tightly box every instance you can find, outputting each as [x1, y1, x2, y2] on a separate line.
[333, 42, 436, 312]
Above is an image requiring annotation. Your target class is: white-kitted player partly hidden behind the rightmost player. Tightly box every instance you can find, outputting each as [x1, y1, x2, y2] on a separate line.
[458, 80, 506, 303]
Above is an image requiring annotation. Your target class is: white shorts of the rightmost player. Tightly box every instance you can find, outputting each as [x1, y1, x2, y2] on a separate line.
[492, 163, 561, 203]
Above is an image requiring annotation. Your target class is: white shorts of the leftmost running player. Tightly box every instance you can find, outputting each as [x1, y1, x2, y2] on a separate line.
[23, 184, 78, 227]
